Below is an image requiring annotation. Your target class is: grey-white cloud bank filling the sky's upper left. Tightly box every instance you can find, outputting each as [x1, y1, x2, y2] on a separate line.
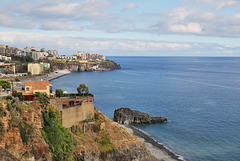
[0, 0, 114, 31]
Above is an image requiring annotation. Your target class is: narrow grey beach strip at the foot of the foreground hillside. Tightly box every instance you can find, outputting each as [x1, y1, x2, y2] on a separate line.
[117, 123, 184, 161]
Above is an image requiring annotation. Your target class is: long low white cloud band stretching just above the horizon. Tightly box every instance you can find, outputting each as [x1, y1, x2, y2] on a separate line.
[0, 32, 240, 55]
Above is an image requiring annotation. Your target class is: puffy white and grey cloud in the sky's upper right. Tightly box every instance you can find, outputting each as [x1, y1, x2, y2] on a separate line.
[144, 0, 240, 38]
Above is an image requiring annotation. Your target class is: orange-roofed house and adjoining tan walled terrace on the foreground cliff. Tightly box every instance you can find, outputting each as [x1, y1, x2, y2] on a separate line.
[17, 80, 94, 128]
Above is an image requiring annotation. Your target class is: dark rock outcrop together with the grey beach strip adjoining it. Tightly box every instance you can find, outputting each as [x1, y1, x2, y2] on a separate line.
[113, 108, 183, 161]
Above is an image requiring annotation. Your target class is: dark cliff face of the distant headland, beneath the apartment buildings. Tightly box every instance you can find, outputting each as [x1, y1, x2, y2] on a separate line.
[50, 60, 121, 72]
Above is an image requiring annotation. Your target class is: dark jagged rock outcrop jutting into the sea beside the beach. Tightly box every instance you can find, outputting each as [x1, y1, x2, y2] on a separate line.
[113, 108, 167, 124]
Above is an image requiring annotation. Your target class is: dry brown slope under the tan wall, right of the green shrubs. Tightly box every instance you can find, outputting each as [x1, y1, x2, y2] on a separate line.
[72, 110, 149, 161]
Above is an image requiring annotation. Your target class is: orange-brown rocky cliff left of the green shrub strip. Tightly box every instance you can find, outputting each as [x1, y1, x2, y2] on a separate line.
[0, 102, 51, 160]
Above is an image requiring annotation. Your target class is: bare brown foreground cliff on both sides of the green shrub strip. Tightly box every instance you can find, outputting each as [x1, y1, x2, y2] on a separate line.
[0, 101, 149, 161]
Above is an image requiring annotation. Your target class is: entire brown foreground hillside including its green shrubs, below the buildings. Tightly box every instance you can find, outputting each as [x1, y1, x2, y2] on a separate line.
[0, 100, 149, 161]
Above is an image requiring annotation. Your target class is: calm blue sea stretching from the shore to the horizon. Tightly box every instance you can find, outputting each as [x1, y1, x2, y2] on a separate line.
[51, 57, 240, 161]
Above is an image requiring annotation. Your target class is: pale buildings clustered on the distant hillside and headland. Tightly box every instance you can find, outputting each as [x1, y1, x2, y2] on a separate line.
[0, 45, 106, 77]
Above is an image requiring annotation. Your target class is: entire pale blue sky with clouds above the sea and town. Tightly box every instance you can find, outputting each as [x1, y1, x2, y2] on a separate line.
[0, 0, 240, 57]
